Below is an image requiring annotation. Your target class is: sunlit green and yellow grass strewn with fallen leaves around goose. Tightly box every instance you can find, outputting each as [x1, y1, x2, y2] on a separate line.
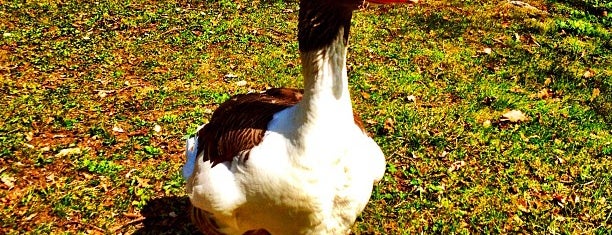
[0, 0, 612, 234]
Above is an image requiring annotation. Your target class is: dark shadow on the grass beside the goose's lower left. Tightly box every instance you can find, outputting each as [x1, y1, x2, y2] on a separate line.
[134, 196, 201, 234]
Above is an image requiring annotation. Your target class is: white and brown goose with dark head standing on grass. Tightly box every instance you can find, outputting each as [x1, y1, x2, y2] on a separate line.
[183, 0, 407, 234]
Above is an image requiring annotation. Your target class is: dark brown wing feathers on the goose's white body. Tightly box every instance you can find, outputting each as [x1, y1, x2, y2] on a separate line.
[197, 88, 365, 166]
